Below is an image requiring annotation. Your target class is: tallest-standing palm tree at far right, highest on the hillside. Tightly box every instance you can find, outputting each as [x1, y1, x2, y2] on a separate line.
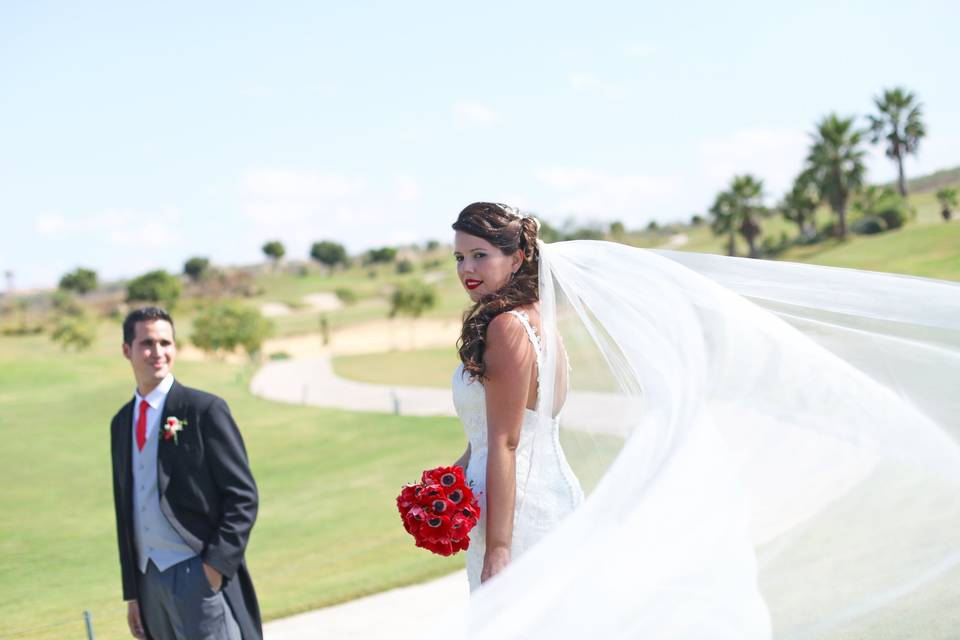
[868, 87, 927, 197]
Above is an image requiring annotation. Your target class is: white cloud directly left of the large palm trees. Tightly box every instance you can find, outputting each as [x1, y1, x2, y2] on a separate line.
[696, 128, 810, 199]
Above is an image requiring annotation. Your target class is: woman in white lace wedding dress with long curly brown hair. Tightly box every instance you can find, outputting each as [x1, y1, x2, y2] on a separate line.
[453, 202, 583, 590]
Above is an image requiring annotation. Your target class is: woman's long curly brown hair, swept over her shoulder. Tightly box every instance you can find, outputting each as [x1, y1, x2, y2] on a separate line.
[453, 202, 540, 381]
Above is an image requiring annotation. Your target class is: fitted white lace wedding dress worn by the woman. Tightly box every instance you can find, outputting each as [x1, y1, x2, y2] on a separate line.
[453, 310, 583, 591]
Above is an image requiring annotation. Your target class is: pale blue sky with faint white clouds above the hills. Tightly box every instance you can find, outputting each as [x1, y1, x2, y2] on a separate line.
[0, 1, 960, 288]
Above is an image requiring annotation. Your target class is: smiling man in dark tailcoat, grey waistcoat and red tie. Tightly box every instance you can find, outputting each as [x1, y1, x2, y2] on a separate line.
[110, 307, 263, 640]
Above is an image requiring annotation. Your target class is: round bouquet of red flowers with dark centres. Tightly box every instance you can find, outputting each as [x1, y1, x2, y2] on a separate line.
[397, 467, 480, 556]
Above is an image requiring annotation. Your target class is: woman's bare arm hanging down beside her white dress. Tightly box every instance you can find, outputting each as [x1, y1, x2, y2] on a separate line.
[481, 313, 536, 580]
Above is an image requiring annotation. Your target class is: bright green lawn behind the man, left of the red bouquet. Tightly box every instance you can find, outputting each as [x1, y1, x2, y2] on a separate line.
[0, 326, 463, 638]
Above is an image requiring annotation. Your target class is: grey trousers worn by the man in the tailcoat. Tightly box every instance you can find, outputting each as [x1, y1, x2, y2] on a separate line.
[137, 556, 241, 640]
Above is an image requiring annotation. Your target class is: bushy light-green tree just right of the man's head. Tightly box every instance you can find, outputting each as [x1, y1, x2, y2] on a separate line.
[190, 302, 273, 358]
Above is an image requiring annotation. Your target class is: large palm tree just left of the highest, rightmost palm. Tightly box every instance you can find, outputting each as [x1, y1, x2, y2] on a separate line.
[807, 113, 866, 239]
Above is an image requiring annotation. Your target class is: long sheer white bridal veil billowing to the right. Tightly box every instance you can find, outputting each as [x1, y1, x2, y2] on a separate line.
[458, 241, 960, 640]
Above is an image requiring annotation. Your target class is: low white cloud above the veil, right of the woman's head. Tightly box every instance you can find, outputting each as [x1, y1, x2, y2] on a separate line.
[535, 167, 680, 224]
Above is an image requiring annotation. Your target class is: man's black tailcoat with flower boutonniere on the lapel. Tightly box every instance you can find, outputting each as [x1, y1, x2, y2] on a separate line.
[110, 381, 263, 640]
